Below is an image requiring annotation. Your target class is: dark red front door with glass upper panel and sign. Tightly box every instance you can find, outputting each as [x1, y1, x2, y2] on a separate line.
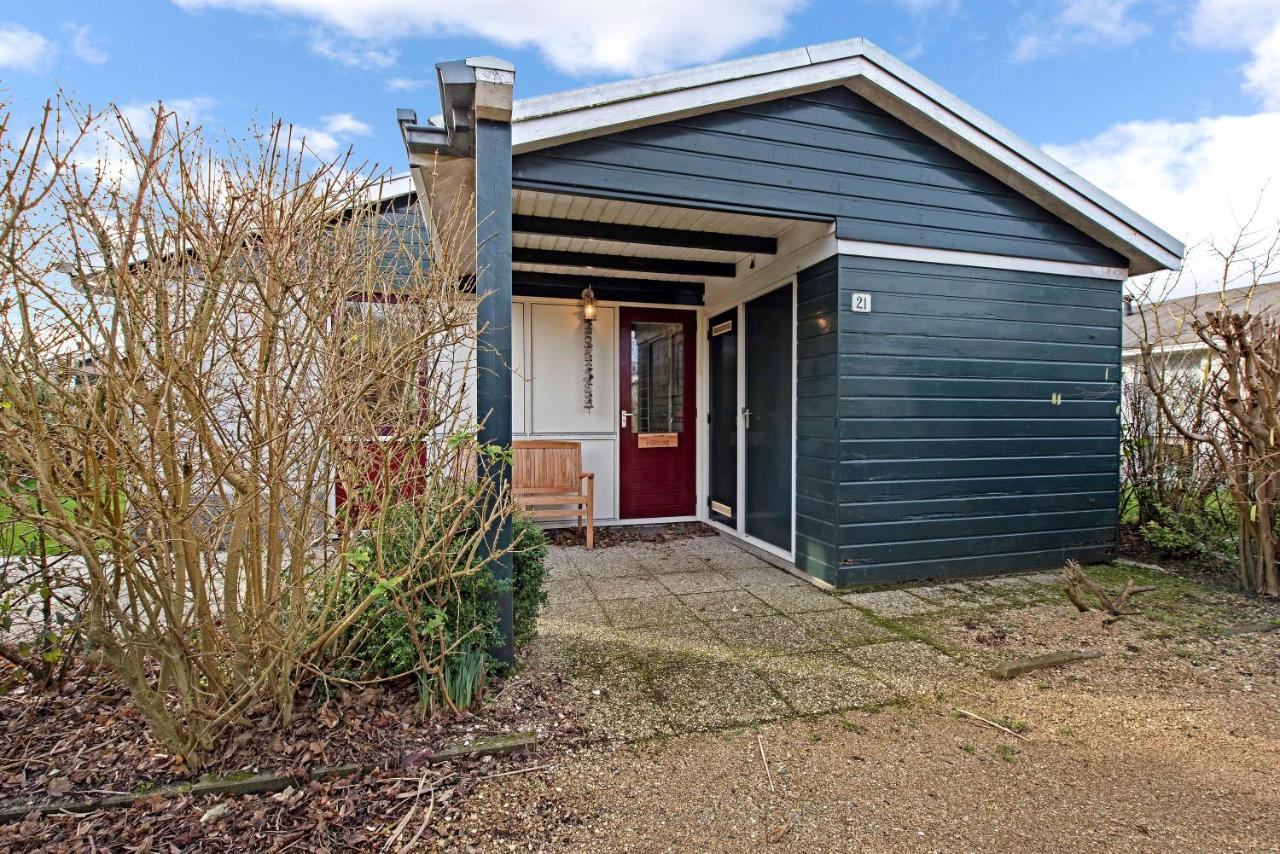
[618, 307, 698, 519]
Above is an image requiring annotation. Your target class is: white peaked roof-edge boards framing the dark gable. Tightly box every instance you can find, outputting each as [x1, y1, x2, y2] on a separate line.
[404, 38, 1183, 275]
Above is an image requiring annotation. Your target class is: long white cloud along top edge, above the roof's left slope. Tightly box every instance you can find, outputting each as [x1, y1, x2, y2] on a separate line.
[173, 0, 805, 74]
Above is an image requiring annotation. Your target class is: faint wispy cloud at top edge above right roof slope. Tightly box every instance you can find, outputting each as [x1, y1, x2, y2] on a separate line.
[1012, 0, 1151, 63]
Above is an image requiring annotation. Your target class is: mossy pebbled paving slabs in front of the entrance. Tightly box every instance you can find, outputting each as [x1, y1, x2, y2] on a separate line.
[524, 535, 1061, 739]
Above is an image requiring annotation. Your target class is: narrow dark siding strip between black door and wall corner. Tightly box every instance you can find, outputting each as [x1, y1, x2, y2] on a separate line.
[795, 257, 840, 584]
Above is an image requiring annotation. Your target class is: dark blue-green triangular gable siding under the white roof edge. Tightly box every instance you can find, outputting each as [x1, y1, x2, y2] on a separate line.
[513, 87, 1125, 265]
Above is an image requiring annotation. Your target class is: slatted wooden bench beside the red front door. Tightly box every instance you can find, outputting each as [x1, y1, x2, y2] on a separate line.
[511, 439, 595, 548]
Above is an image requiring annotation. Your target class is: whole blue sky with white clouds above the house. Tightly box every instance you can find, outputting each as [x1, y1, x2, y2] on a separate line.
[0, 0, 1280, 290]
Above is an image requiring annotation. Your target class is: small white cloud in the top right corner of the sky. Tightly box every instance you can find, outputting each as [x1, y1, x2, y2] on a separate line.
[1187, 0, 1280, 110]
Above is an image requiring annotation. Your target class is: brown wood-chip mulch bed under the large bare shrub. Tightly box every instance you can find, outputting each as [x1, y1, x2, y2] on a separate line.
[0, 665, 590, 851]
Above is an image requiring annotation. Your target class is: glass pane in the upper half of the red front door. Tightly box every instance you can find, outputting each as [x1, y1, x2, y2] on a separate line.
[631, 323, 685, 433]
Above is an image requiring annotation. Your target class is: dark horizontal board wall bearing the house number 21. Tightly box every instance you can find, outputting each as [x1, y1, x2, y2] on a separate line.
[834, 256, 1120, 585]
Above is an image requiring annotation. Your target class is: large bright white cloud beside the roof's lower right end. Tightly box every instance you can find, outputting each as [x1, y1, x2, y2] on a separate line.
[1046, 113, 1280, 293]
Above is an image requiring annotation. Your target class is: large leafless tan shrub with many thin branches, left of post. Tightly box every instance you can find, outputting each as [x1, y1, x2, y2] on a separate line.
[0, 96, 509, 764]
